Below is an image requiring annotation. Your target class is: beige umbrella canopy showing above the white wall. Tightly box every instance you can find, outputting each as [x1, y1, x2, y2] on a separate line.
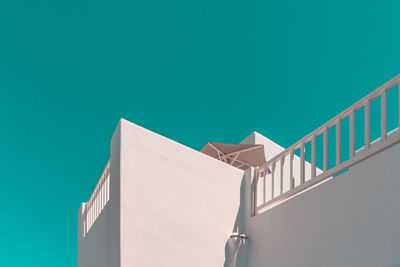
[200, 142, 266, 170]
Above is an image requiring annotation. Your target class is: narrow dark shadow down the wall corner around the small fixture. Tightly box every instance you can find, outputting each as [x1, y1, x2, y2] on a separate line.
[224, 169, 251, 267]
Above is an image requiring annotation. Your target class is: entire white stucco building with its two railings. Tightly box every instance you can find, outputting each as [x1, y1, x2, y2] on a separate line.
[78, 76, 400, 267]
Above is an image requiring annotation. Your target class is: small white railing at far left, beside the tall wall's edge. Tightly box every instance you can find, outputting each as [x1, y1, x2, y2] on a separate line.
[83, 161, 110, 235]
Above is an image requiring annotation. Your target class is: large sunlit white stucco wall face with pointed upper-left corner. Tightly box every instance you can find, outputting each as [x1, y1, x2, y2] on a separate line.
[120, 120, 243, 267]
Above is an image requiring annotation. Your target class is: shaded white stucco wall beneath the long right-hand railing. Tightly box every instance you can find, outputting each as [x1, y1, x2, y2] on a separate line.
[236, 145, 400, 267]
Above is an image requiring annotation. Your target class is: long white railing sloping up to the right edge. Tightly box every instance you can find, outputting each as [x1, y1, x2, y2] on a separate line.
[253, 74, 400, 214]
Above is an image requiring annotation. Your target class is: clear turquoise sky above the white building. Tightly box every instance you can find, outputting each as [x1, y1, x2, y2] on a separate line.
[0, 0, 400, 267]
